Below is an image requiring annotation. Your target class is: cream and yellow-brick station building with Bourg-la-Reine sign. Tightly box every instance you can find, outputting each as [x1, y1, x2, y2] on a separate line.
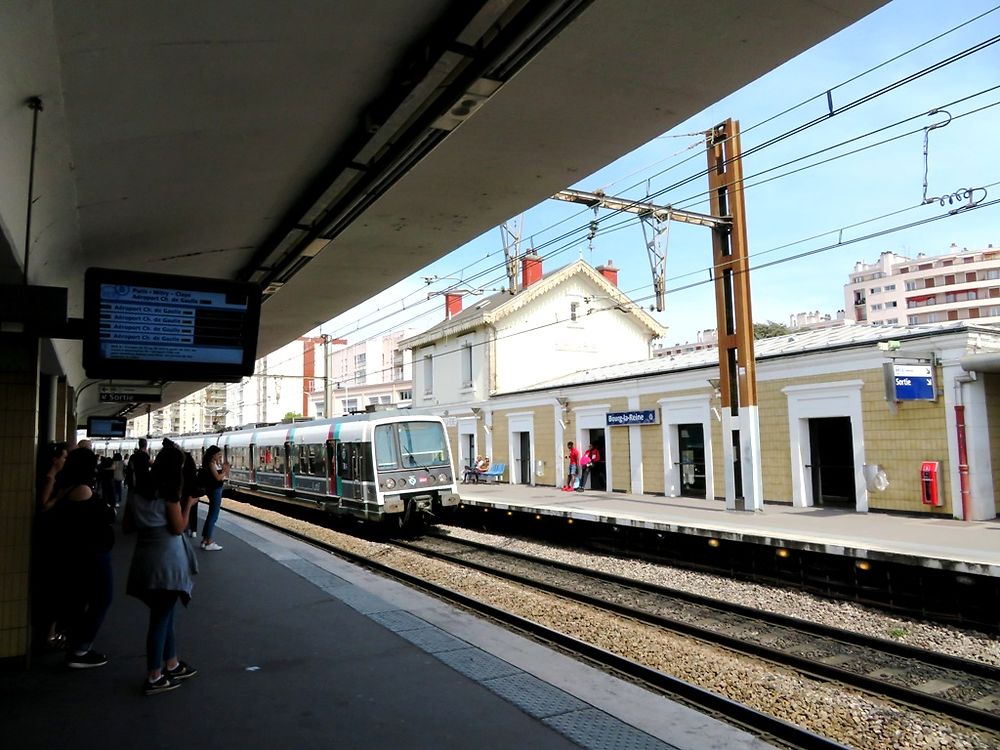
[403, 262, 1000, 520]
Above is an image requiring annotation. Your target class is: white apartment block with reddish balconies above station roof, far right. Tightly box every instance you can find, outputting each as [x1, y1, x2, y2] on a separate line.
[844, 245, 1000, 326]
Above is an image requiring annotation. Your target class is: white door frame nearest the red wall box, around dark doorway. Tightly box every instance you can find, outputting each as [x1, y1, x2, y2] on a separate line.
[781, 380, 868, 513]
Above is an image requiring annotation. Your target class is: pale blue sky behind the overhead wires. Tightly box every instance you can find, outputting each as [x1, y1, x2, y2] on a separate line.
[314, 0, 1000, 350]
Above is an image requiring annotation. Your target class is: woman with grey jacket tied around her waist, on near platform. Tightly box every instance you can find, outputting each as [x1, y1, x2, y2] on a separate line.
[126, 444, 198, 695]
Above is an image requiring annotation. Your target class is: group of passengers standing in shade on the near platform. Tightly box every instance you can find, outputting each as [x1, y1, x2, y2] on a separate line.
[36, 439, 229, 695]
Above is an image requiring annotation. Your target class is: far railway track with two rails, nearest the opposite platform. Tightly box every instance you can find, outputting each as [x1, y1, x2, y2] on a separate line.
[392, 535, 1000, 733]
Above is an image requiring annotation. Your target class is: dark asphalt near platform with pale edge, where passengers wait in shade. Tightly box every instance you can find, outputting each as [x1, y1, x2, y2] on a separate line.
[0, 511, 767, 750]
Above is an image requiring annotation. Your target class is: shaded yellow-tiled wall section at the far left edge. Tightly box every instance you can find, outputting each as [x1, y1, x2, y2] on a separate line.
[0, 340, 38, 660]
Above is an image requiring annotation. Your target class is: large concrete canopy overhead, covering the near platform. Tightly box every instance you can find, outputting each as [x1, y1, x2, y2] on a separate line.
[0, 0, 883, 418]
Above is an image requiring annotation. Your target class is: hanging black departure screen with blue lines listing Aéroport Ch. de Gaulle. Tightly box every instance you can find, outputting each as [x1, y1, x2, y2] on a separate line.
[84, 269, 260, 382]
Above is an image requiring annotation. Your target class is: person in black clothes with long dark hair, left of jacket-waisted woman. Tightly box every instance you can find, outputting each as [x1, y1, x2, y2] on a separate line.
[51, 448, 115, 669]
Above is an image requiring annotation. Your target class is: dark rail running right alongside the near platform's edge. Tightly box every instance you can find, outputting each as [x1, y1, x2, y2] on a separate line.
[226, 500, 848, 750]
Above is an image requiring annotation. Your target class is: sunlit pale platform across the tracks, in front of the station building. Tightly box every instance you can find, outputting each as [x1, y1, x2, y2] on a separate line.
[460, 482, 1000, 577]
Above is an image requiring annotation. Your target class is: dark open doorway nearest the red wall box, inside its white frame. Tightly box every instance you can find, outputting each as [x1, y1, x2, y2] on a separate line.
[808, 417, 857, 508]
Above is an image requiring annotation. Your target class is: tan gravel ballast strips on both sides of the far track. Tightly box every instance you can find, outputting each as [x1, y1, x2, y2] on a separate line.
[225, 500, 1000, 750]
